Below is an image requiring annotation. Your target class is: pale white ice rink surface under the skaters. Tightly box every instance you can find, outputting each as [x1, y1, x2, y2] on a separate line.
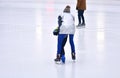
[0, 0, 120, 78]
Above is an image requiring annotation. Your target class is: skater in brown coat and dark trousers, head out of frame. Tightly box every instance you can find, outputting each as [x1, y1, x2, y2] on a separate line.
[76, 0, 86, 26]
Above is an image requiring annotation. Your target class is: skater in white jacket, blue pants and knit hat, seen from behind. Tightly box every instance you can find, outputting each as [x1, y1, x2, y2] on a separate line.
[55, 5, 76, 63]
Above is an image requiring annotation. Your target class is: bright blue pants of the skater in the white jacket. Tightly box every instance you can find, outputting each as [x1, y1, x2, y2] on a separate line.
[57, 34, 75, 54]
